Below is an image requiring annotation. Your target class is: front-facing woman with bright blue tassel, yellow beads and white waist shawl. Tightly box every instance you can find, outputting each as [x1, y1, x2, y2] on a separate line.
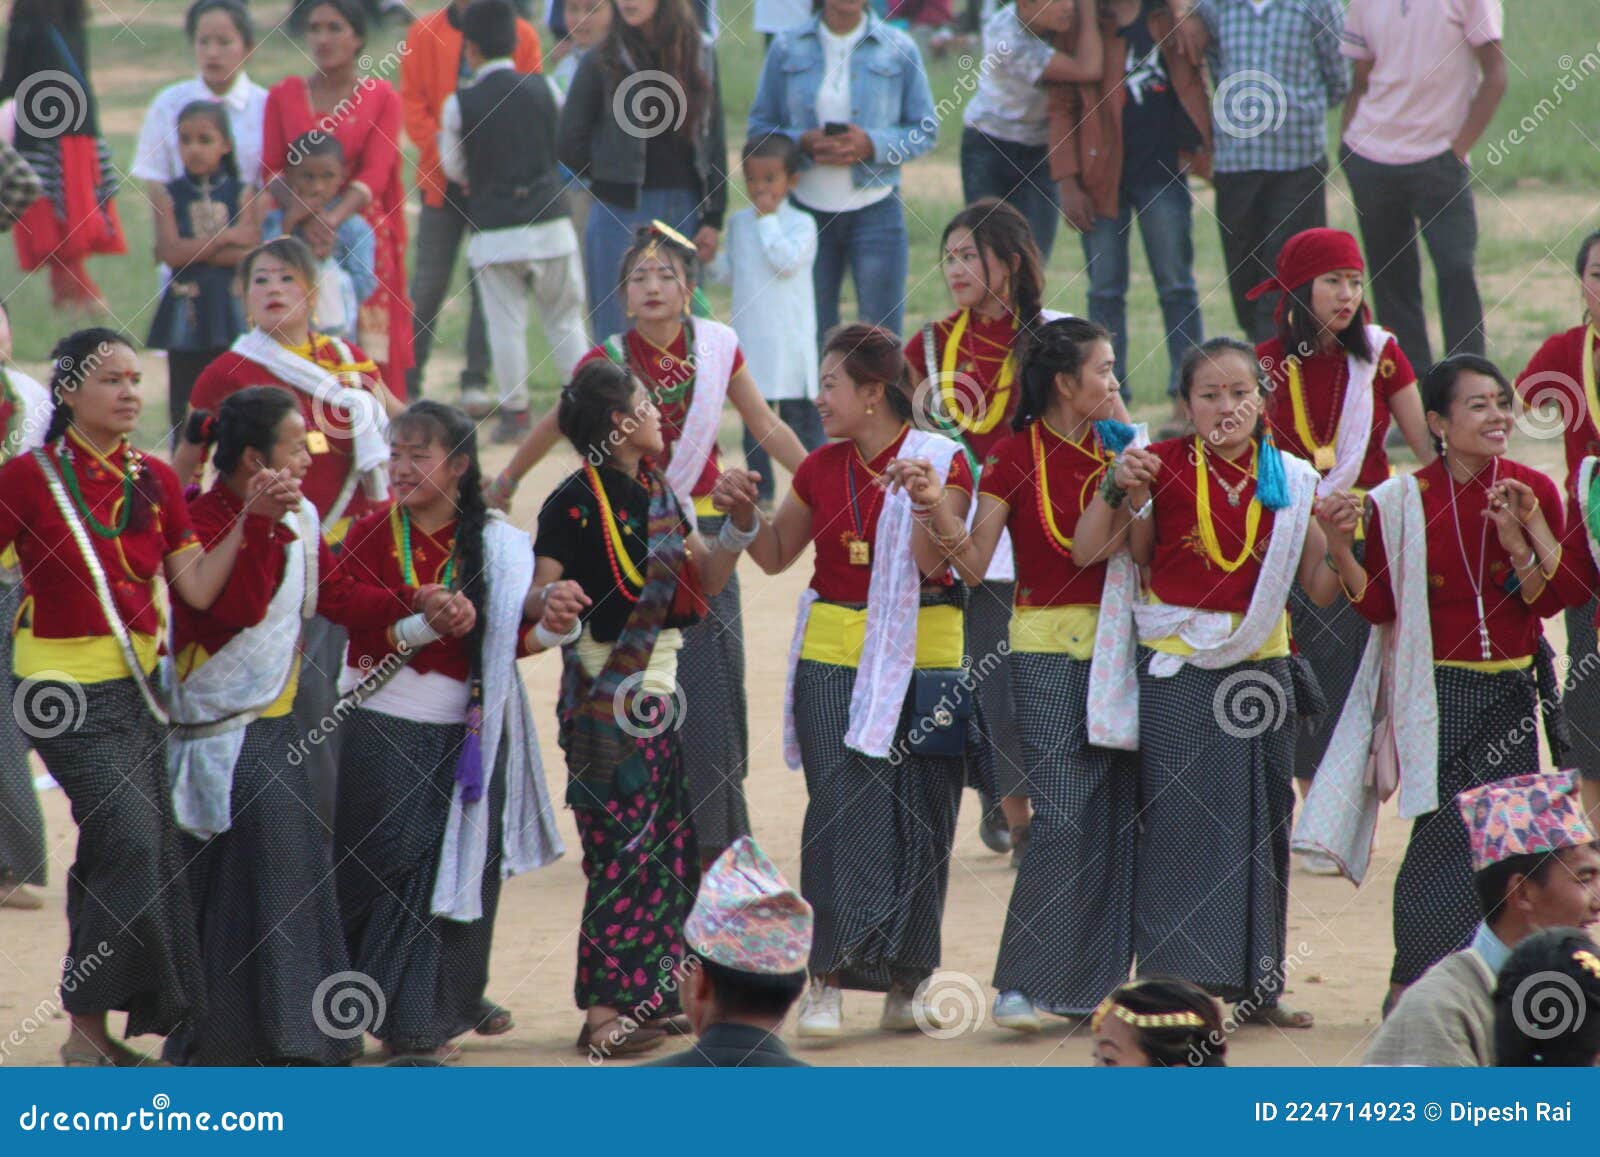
[1074, 338, 1339, 1029]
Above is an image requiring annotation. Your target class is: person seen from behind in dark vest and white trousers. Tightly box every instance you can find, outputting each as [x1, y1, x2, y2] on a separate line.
[438, 0, 589, 442]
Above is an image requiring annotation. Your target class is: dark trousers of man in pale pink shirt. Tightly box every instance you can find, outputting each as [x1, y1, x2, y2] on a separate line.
[1339, 149, 1483, 378]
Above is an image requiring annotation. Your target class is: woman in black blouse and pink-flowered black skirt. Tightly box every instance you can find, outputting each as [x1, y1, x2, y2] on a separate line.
[530, 360, 755, 1056]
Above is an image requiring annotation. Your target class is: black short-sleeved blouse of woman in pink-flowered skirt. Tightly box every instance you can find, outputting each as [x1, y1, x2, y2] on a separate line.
[533, 466, 696, 643]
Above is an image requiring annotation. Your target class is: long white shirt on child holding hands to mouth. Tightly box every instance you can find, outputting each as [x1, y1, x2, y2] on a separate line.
[723, 202, 818, 402]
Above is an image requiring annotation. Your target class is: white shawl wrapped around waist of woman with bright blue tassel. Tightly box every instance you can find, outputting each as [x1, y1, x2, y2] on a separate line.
[1088, 454, 1318, 751]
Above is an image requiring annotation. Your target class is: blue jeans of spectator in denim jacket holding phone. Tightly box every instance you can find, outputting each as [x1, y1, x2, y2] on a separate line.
[795, 192, 910, 341]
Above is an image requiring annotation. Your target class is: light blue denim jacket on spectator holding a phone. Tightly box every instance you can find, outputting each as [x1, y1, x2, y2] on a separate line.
[746, 11, 939, 189]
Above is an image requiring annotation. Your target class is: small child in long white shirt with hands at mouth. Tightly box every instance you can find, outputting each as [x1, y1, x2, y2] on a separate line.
[728, 133, 827, 502]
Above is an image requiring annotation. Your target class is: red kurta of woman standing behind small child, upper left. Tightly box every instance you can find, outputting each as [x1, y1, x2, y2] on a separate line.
[261, 77, 413, 398]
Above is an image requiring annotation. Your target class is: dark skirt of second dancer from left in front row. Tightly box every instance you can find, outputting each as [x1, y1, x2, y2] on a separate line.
[165, 715, 362, 1064]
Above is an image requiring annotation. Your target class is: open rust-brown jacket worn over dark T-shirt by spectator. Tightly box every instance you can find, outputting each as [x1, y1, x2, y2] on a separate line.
[1046, 5, 1211, 218]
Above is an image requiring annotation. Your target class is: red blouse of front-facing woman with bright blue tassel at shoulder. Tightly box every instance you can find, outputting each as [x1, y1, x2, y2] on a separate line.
[1150, 438, 1274, 615]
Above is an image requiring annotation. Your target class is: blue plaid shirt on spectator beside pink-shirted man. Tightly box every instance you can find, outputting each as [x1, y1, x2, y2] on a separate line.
[1195, 0, 1350, 173]
